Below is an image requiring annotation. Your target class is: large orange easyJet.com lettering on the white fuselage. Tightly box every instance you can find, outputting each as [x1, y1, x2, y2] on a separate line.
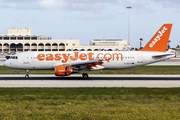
[37, 52, 123, 63]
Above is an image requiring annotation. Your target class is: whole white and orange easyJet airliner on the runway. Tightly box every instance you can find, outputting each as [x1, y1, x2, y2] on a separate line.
[4, 24, 175, 78]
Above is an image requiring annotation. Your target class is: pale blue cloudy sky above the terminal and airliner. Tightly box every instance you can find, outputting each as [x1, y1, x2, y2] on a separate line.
[0, 0, 180, 47]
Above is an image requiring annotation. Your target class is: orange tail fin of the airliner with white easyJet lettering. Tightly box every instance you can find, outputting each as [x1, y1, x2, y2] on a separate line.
[139, 24, 172, 52]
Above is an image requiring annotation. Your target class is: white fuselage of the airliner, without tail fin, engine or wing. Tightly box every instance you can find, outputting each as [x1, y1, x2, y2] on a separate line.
[4, 51, 175, 70]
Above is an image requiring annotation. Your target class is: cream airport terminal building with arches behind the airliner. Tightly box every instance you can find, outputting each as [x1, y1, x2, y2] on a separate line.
[0, 29, 128, 53]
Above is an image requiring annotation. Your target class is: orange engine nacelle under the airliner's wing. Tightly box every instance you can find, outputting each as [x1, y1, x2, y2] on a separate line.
[55, 66, 72, 76]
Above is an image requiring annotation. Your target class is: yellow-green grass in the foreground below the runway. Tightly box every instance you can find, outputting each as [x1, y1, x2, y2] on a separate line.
[0, 88, 180, 120]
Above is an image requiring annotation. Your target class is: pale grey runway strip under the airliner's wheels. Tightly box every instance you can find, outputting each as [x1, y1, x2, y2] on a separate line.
[0, 75, 180, 88]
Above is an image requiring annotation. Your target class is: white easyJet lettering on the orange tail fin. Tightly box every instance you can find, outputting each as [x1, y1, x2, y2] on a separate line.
[149, 27, 167, 48]
